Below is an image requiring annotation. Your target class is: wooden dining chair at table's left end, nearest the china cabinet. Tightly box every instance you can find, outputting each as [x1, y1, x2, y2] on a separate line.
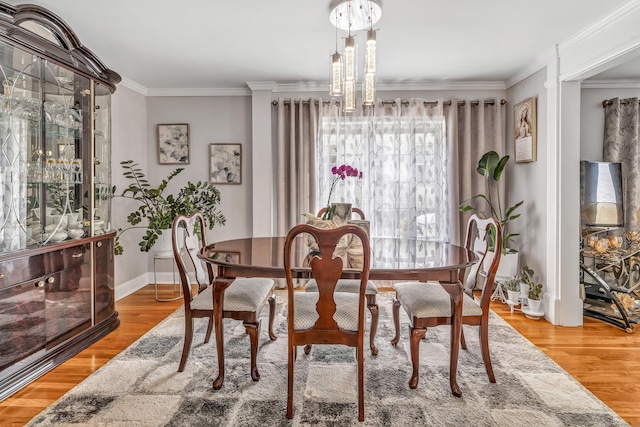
[171, 212, 277, 381]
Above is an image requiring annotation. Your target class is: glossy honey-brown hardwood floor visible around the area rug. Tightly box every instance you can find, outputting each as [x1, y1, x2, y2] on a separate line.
[0, 285, 640, 426]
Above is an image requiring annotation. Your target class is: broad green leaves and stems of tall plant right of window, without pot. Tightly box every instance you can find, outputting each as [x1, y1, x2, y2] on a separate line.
[460, 151, 524, 255]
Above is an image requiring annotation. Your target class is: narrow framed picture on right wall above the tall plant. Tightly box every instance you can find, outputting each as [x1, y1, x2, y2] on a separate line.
[513, 98, 536, 163]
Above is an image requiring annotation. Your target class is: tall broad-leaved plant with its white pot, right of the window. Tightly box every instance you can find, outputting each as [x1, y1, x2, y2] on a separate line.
[460, 151, 524, 277]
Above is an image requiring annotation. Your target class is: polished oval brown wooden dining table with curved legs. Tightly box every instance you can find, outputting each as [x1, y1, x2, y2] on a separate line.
[198, 235, 478, 397]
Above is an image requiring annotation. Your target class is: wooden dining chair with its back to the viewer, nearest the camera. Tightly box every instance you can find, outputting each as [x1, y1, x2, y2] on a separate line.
[284, 224, 371, 421]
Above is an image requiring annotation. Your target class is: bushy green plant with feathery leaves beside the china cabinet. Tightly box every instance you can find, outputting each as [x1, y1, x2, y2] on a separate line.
[111, 160, 226, 255]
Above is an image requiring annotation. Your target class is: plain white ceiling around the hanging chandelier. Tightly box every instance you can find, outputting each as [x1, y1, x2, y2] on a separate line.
[2, 0, 637, 90]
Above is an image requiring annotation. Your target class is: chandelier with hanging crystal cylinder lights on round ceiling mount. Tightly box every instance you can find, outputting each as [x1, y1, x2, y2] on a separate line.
[329, 0, 382, 113]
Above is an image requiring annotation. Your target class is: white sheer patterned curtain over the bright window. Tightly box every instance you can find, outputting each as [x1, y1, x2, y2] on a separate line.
[315, 99, 452, 267]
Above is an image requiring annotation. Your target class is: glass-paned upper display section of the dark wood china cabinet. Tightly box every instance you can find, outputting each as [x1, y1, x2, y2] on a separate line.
[0, 37, 111, 254]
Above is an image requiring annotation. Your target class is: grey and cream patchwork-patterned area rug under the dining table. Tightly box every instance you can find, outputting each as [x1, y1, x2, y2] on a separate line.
[28, 291, 627, 427]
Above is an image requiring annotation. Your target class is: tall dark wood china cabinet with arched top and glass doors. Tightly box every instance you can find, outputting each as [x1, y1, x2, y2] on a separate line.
[0, 2, 120, 399]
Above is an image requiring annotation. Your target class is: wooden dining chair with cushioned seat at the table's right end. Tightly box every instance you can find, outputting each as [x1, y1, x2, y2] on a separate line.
[391, 215, 502, 388]
